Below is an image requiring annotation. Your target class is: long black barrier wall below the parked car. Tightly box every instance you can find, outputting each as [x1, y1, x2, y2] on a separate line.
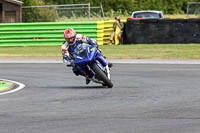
[125, 18, 200, 44]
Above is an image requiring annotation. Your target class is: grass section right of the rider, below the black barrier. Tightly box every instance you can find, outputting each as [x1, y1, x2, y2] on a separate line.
[102, 44, 200, 59]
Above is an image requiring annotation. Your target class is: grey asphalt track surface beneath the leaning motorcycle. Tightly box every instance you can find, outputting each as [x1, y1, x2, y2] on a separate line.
[0, 59, 200, 133]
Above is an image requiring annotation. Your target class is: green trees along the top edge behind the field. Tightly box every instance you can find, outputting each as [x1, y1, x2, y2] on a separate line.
[20, 0, 200, 14]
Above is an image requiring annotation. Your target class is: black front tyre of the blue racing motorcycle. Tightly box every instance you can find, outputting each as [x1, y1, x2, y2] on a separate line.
[93, 65, 113, 88]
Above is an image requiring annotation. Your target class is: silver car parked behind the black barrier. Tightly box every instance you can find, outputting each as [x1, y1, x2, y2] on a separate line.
[131, 10, 164, 19]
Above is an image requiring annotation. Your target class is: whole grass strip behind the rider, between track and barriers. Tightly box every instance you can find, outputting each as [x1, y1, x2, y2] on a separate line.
[0, 44, 200, 59]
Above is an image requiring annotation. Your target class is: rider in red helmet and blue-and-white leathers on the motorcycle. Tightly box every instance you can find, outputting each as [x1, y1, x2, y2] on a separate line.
[61, 28, 112, 84]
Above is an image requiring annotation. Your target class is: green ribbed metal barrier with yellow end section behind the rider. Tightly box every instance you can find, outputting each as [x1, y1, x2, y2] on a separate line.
[0, 20, 126, 46]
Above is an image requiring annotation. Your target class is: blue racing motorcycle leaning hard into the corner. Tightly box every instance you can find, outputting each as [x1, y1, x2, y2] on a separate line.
[73, 44, 113, 88]
